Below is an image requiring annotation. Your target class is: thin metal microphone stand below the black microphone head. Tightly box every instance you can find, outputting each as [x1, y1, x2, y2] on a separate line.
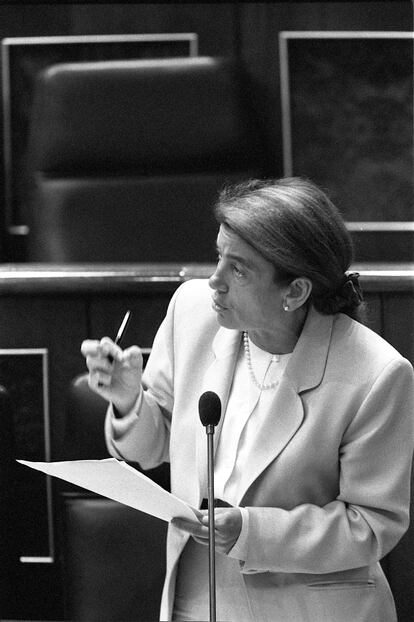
[206, 425, 216, 622]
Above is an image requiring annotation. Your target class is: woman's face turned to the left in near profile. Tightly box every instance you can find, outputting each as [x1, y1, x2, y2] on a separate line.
[209, 225, 289, 341]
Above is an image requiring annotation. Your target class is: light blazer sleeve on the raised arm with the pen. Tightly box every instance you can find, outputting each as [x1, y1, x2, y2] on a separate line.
[105, 282, 178, 469]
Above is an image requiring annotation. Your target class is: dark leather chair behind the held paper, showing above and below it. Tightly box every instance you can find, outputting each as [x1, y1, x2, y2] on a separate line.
[58, 374, 169, 622]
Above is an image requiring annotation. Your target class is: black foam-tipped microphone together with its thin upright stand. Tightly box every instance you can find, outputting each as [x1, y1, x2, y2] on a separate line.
[198, 391, 221, 622]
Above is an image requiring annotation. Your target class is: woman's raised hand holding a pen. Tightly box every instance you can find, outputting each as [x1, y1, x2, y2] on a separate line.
[81, 337, 142, 415]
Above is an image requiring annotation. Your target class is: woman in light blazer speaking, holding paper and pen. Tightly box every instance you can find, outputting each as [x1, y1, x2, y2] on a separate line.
[82, 178, 413, 622]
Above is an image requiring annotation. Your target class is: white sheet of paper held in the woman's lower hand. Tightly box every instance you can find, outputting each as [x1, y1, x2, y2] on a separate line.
[17, 458, 198, 522]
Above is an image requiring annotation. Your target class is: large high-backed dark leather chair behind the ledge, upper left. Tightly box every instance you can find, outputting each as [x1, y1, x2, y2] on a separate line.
[27, 57, 268, 263]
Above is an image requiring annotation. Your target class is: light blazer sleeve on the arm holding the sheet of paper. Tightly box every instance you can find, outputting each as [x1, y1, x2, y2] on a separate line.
[241, 358, 414, 573]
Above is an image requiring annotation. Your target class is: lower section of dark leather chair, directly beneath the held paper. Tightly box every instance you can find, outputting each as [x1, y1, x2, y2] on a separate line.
[63, 493, 166, 622]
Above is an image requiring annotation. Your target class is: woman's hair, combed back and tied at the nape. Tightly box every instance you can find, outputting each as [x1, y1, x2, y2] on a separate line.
[214, 177, 362, 321]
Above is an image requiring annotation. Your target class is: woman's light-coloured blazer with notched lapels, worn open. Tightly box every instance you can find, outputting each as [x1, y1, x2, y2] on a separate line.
[106, 280, 414, 622]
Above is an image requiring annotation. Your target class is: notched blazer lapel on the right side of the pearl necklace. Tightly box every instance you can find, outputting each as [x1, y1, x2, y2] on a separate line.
[238, 308, 333, 503]
